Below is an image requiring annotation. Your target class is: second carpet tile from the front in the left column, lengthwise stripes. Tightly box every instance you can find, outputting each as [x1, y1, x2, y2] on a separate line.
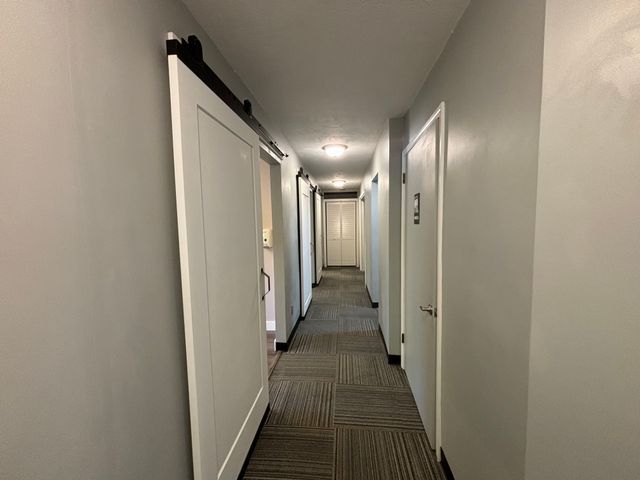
[267, 381, 335, 427]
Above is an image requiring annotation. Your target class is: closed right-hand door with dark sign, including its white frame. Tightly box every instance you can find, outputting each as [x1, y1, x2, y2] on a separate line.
[401, 104, 446, 460]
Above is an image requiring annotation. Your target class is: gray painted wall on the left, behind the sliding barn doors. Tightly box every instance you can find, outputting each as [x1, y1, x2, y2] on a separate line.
[0, 0, 306, 480]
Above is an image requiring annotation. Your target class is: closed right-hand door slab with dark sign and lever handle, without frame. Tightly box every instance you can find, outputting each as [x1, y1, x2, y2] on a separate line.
[404, 122, 438, 448]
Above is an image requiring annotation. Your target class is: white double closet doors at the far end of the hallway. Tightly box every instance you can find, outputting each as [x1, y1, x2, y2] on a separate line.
[325, 201, 357, 267]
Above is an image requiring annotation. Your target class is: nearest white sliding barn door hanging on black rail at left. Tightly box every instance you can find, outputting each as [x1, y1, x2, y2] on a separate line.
[169, 50, 269, 480]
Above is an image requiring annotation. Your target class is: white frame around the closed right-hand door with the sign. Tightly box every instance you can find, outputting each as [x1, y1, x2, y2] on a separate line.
[400, 101, 447, 461]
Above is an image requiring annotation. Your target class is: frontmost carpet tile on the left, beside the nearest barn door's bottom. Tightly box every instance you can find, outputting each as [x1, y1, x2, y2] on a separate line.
[243, 425, 335, 480]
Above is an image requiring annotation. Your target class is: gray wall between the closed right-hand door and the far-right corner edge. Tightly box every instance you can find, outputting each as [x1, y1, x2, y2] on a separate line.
[406, 0, 544, 480]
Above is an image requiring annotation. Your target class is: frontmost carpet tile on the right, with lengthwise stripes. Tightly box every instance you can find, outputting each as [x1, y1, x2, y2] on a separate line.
[336, 429, 444, 480]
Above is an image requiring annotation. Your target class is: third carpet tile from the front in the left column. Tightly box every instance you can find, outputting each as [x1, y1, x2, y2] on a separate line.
[270, 353, 338, 382]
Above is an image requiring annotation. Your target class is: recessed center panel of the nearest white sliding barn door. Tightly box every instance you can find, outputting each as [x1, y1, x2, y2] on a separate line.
[198, 110, 261, 468]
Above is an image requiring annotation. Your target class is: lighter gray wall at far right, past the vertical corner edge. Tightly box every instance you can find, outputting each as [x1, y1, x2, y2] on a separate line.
[526, 0, 640, 480]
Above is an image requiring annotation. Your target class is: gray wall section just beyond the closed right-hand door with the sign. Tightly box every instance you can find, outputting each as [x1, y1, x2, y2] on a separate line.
[360, 118, 405, 355]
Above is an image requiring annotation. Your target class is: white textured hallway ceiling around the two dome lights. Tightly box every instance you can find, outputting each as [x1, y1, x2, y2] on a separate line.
[184, 0, 469, 190]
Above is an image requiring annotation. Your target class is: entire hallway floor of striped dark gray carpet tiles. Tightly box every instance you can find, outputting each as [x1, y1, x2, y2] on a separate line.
[244, 268, 444, 480]
